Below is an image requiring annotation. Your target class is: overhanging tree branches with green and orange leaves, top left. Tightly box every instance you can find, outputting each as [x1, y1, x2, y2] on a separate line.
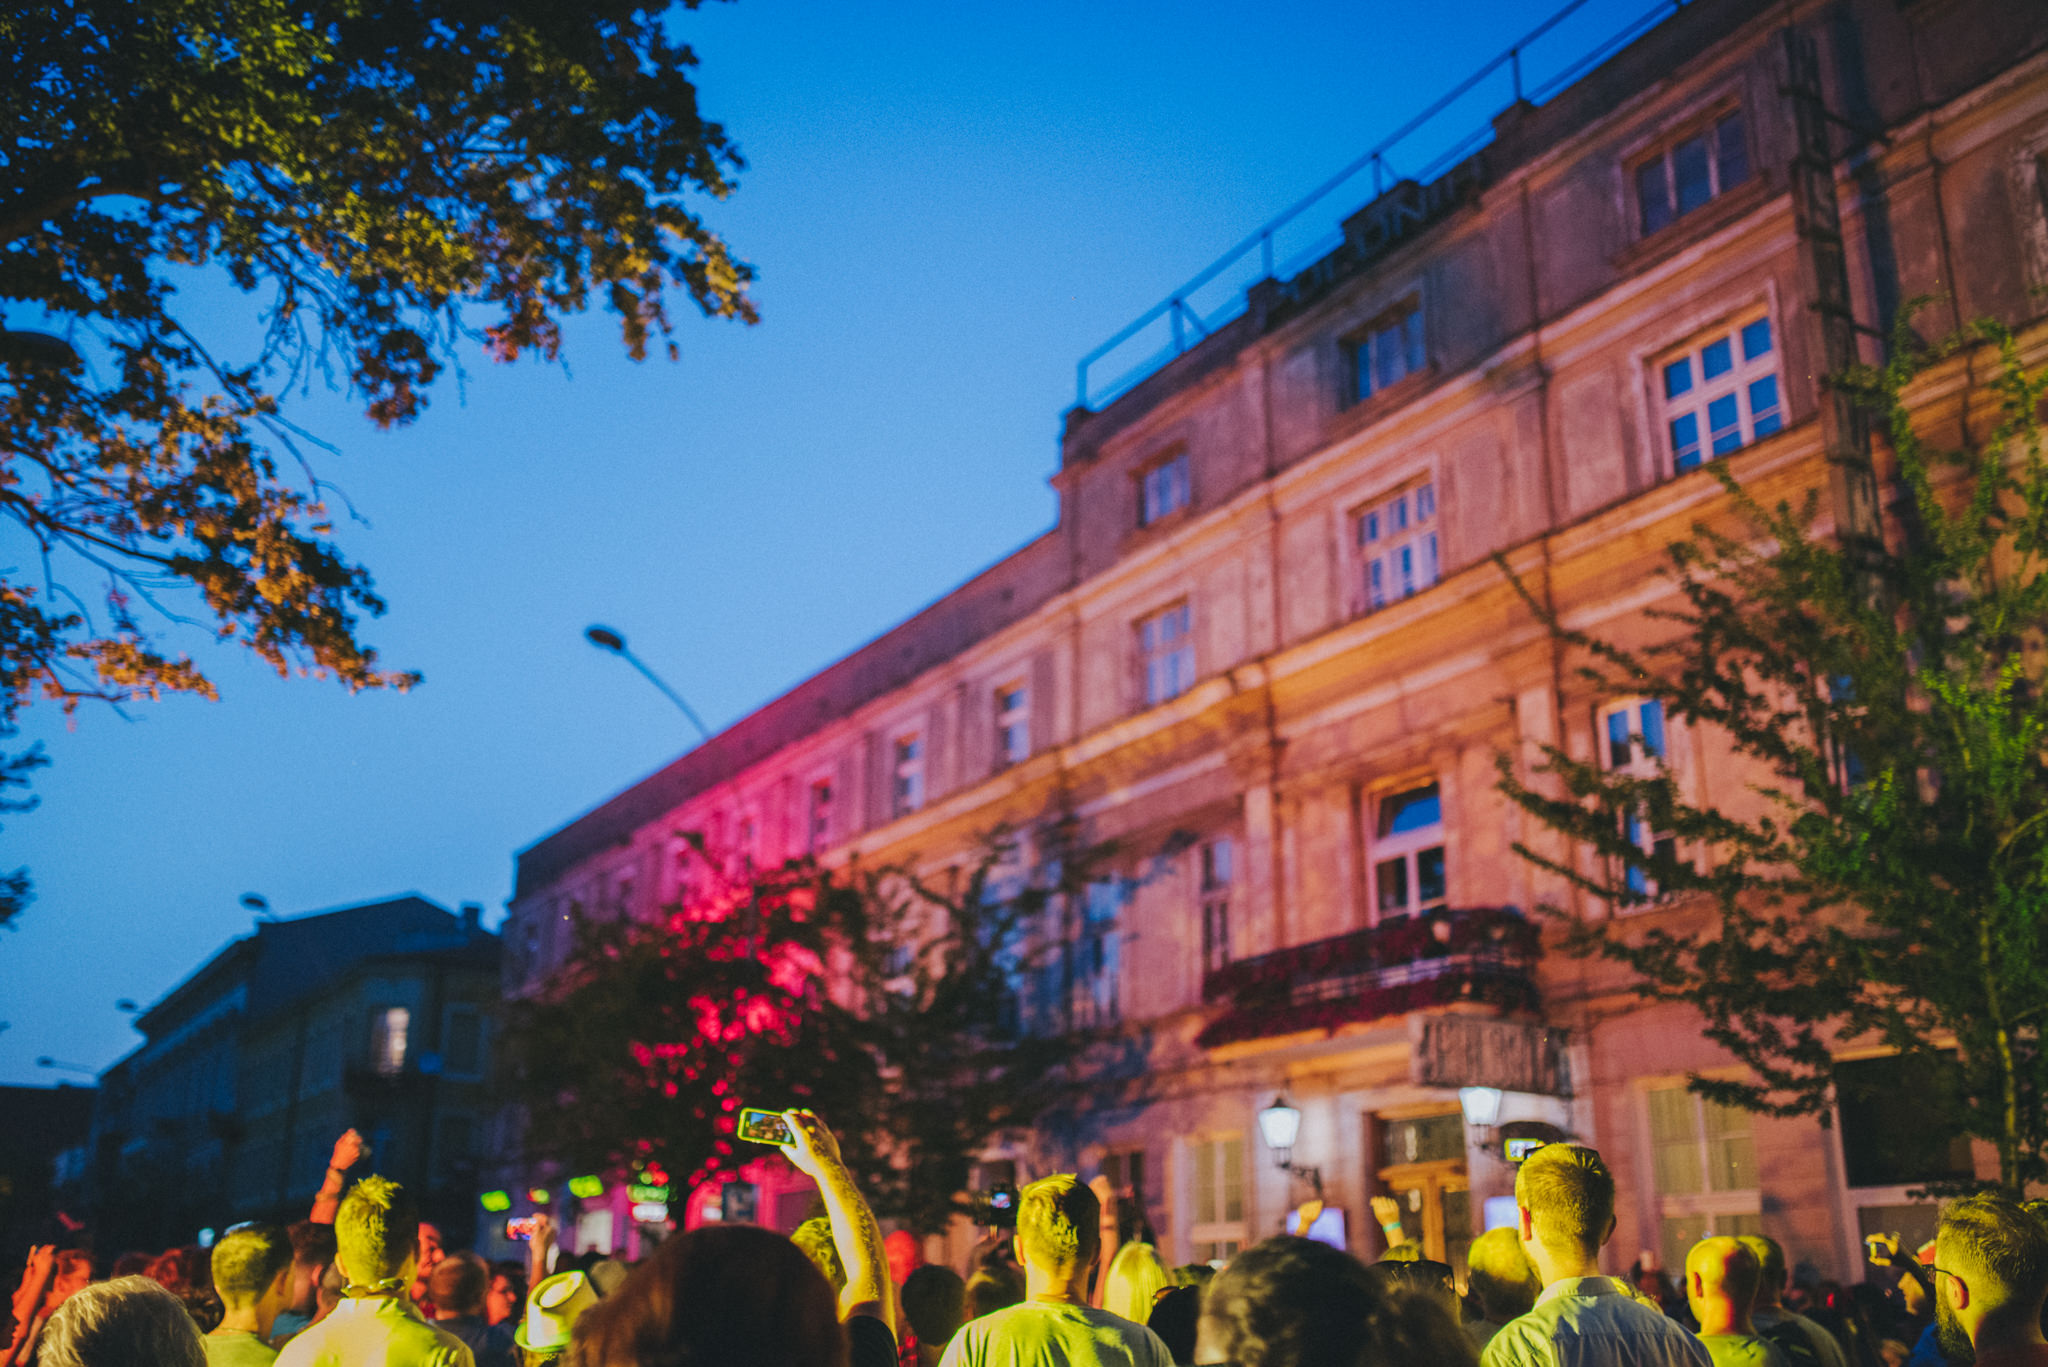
[0, 0, 754, 922]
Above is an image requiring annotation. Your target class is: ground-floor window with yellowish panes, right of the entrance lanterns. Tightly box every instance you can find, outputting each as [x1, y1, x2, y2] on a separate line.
[1642, 1082, 1763, 1267]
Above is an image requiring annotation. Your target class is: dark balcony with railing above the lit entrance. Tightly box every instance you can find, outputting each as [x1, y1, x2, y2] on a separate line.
[1196, 906, 1542, 1049]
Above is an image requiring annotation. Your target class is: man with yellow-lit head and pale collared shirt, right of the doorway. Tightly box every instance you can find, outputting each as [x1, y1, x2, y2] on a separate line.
[1479, 1144, 1712, 1367]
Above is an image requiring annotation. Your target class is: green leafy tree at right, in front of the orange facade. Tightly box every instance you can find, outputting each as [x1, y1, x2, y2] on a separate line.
[1501, 322, 2048, 1189]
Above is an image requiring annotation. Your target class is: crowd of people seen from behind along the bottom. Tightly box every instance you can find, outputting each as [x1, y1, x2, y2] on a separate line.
[12, 1111, 2048, 1367]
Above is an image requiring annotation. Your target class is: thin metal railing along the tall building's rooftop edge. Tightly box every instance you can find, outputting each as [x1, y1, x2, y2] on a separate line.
[1075, 0, 1686, 408]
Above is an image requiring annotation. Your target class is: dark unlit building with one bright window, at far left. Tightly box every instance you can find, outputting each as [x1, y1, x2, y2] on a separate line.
[90, 896, 500, 1248]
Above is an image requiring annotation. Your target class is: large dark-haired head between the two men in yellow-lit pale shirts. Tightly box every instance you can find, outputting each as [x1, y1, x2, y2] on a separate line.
[1196, 1234, 1475, 1367]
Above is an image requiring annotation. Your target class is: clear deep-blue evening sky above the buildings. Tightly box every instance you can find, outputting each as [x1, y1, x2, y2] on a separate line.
[0, 0, 1669, 1084]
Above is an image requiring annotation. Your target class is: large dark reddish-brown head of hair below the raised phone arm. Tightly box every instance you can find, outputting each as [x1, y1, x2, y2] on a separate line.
[569, 1226, 846, 1367]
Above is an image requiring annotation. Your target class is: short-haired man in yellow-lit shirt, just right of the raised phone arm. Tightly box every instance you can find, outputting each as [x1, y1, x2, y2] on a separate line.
[940, 1172, 1174, 1367]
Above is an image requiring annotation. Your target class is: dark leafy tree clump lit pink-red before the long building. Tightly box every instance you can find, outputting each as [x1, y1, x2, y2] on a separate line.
[508, 827, 1085, 1232]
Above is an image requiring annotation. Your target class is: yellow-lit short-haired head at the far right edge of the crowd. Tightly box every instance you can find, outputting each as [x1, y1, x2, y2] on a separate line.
[1933, 1191, 2048, 1357]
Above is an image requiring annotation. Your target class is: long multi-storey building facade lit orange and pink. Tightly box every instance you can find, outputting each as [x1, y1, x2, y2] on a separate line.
[504, 0, 2048, 1277]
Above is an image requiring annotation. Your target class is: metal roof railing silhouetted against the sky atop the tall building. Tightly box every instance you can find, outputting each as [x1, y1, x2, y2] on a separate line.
[1075, 0, 1688, 408]
